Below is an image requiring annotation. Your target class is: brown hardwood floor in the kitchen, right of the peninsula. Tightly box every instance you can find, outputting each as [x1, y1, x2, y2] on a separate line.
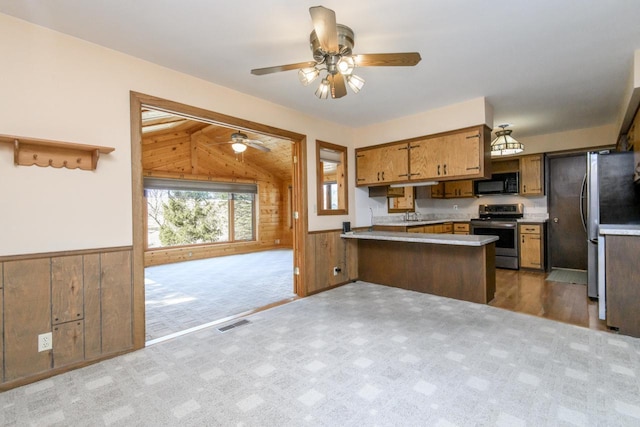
[489, 268, 609, 331]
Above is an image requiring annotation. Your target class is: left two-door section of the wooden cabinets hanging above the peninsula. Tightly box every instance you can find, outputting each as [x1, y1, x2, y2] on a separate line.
[356, 142, 409, 185]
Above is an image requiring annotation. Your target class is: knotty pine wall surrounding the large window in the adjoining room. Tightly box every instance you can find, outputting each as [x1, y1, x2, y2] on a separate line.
[142, 132, 293, 266]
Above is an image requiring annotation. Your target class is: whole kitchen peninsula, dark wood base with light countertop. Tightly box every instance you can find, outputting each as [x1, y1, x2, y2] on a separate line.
[341, 231, 498, 304]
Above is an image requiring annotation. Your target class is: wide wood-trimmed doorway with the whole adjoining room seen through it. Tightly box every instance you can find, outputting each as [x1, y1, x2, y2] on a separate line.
[131, 93, 305, 347]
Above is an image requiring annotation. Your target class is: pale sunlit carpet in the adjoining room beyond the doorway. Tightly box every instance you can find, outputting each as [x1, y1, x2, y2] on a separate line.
[145, 249, 295, 341]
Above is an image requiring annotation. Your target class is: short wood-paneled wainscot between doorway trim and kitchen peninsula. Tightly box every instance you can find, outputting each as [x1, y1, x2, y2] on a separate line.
[305, 230, 358, 294]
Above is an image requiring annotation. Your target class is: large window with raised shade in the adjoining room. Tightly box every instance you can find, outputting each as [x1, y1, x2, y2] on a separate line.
[144, 178, 257, 249]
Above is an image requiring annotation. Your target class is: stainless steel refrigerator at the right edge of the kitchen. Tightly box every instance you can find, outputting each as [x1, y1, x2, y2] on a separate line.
[580, 151, 640, 298]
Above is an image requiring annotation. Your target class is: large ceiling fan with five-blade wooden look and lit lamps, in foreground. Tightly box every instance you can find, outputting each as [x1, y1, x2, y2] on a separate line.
[251, 6, 421, 99]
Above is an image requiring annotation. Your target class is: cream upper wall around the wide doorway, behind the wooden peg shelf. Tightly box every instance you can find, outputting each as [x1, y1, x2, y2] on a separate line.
[0, 14, 355, 256]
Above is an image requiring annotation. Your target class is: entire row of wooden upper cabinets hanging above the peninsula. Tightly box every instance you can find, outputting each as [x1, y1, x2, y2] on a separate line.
[356, 126, 491, 189]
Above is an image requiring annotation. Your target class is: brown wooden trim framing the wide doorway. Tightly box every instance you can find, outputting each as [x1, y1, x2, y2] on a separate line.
[129, 91, 308, 349]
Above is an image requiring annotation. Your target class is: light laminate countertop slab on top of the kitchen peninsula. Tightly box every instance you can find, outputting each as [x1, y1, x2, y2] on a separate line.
[340, 231, 498, 246]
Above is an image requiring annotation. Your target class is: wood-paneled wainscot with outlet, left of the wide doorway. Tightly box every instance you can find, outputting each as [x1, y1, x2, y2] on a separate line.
[0, 248, 133, 390]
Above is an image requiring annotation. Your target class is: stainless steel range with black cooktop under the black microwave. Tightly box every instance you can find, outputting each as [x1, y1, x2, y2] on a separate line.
[471, 203, 524, 270]
